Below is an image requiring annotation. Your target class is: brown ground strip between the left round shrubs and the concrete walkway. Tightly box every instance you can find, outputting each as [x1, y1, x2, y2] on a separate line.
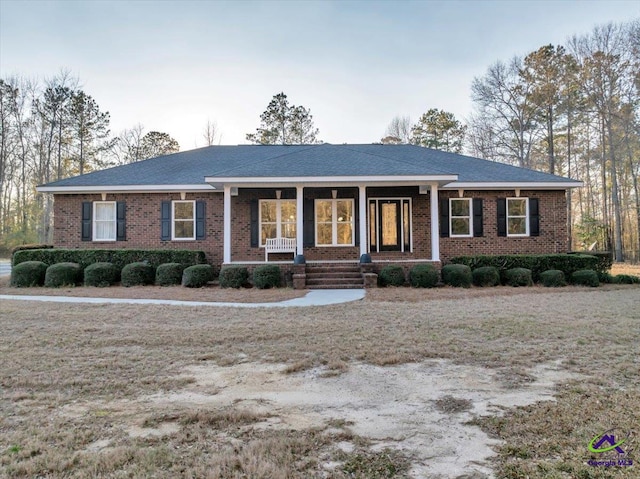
[0, 277, 308, 303]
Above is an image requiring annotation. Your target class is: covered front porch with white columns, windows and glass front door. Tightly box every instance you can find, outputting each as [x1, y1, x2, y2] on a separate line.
[215, 180, 444, 264]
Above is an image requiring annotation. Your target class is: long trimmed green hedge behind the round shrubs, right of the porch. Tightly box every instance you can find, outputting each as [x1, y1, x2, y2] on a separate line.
[451, 253, 610, 282]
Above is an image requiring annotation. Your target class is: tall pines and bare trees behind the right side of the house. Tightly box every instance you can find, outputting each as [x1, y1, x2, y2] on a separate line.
[381, 20, 640, 261]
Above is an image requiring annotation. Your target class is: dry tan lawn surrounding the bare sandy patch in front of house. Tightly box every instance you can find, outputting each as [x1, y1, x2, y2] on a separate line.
[0, 285, 640, 479]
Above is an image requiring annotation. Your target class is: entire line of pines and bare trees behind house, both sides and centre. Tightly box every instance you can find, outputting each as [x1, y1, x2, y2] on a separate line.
[0, 20, 640, 261]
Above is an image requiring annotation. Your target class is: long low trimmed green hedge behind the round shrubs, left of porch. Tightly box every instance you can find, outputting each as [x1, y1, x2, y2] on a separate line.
[13, 248, 206, 269]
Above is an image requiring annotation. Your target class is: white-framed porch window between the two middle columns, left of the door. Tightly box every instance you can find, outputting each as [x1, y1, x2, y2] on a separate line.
[315, 199, 354, 246]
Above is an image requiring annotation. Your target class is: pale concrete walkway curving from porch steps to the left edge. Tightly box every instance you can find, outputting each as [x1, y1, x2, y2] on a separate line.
[0, 289, 365, 308]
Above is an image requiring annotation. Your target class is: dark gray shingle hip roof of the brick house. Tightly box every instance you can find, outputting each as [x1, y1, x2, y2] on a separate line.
[38, 144, 578, 189]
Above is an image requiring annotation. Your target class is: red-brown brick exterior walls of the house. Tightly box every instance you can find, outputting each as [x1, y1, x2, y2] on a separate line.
[54, 187, 567, 266]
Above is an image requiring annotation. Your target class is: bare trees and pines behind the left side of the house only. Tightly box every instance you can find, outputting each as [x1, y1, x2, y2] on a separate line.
[0, 72, 219, 253]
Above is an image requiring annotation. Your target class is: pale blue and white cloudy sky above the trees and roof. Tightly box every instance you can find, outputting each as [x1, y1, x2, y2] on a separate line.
[0, 0, 640, 150]
